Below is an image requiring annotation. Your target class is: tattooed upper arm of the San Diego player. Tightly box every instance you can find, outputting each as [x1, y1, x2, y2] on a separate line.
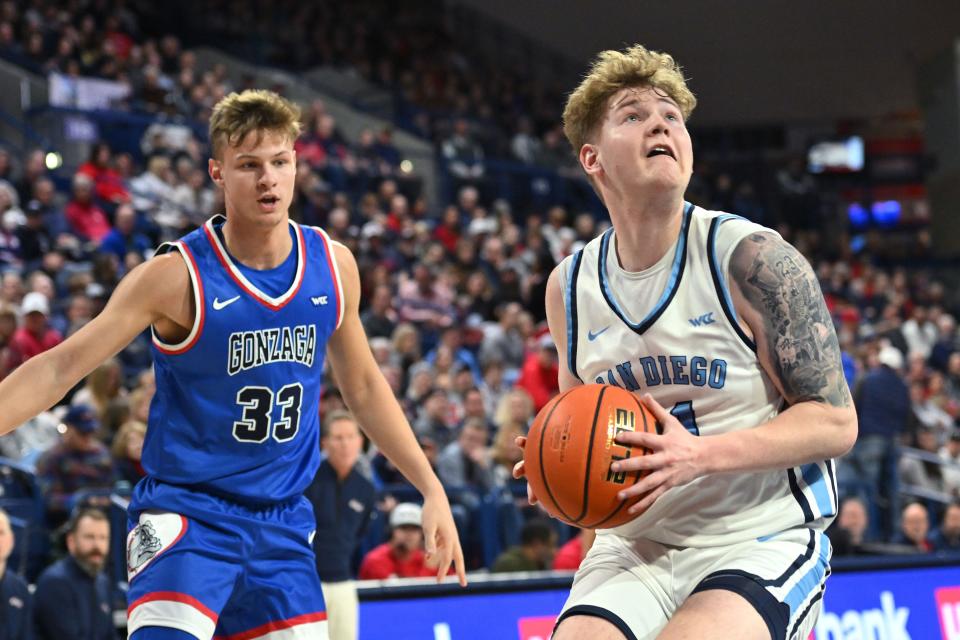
[730, 233, 850, 407]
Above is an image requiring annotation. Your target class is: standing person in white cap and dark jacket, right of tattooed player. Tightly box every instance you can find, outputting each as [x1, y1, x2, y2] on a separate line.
[838, 345, 911, 536]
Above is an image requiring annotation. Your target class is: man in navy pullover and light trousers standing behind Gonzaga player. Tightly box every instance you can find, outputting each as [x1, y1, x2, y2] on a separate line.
[305, 411, 376, 640]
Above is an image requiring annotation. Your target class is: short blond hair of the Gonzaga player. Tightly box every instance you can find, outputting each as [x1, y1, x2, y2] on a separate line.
[210, 89, 300, 160]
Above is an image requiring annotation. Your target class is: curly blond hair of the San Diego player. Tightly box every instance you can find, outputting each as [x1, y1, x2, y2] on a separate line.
[563, 44, 697, 155]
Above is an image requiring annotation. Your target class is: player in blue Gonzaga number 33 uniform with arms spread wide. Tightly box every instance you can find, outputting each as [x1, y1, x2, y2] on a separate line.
[0, 91, 465, 640]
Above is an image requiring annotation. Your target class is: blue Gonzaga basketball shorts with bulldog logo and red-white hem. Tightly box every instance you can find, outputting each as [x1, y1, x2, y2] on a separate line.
[127, 478, 327, 640]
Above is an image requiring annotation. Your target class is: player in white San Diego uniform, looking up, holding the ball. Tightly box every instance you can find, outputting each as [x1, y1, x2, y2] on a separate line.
[515, 46, 857, 640]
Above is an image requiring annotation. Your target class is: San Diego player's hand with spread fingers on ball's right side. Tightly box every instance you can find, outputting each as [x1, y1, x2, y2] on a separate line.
[611, 394, 703, 513]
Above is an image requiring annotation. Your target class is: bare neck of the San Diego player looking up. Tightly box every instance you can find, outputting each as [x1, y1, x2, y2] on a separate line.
[609, 198, 684, 272]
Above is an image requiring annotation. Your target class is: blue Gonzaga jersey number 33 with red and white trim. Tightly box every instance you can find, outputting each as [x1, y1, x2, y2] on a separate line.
[143, 216, 343, 505]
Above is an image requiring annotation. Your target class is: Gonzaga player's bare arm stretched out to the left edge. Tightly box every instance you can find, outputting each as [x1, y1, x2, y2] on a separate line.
[0, 252, 194, 434]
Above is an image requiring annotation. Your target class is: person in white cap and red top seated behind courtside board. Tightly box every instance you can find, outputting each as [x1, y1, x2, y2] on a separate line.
[359, 502, 435, 580]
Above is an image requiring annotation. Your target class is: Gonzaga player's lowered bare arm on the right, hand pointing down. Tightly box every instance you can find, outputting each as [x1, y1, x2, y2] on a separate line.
[327, 243, 467, 586]
